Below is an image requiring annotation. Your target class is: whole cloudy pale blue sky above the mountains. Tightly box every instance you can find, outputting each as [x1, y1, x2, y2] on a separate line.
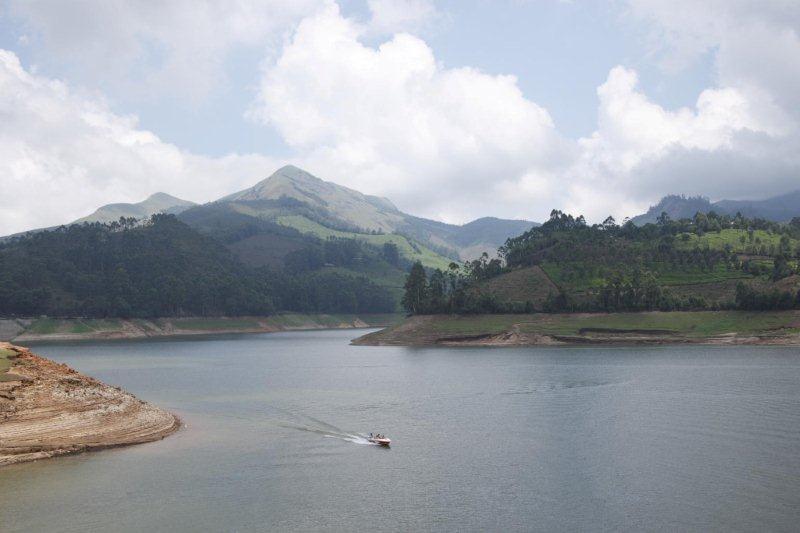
[0, 0, 800, 235]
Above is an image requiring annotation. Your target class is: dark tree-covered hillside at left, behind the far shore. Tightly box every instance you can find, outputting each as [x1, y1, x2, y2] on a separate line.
[0, 215, 396, 317]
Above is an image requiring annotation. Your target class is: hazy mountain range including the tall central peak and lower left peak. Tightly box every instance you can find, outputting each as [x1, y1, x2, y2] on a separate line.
[6, 165, 537, 267]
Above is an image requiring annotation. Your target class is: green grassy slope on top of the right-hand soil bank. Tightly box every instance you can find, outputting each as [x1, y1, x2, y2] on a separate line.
[374, 311, 800, 343]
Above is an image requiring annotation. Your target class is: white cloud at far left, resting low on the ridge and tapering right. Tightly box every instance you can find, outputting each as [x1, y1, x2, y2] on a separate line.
[0, 50, 277, 235]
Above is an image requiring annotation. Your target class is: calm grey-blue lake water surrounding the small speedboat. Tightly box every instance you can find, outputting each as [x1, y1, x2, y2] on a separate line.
[0, 331, 800, 532]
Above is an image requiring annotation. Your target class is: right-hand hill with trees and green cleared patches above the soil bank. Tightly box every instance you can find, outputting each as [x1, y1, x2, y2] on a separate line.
[403, 211, 800, 313]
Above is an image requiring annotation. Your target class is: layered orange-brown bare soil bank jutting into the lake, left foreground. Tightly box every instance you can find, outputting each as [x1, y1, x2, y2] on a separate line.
[0, 342, 180, 466]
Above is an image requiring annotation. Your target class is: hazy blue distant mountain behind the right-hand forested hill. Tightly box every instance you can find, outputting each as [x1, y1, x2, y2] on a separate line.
[631, 190, 800, 226]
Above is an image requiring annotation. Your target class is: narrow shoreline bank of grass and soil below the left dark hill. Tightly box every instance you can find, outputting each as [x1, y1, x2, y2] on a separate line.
[0, 313, 401, 343]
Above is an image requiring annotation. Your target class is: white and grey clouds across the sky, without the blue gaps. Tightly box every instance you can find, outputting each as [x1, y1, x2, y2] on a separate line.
[0, 0, 800, 233]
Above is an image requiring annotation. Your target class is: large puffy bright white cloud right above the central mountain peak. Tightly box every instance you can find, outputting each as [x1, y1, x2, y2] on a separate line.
[251, 4, 565, 220]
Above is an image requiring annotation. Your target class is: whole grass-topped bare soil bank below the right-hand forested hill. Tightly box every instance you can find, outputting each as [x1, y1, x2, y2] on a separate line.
[353, 311, 800, 346]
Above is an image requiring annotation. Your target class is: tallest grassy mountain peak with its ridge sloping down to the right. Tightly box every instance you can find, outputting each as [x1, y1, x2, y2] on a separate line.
[200, 166, 536, 260]
